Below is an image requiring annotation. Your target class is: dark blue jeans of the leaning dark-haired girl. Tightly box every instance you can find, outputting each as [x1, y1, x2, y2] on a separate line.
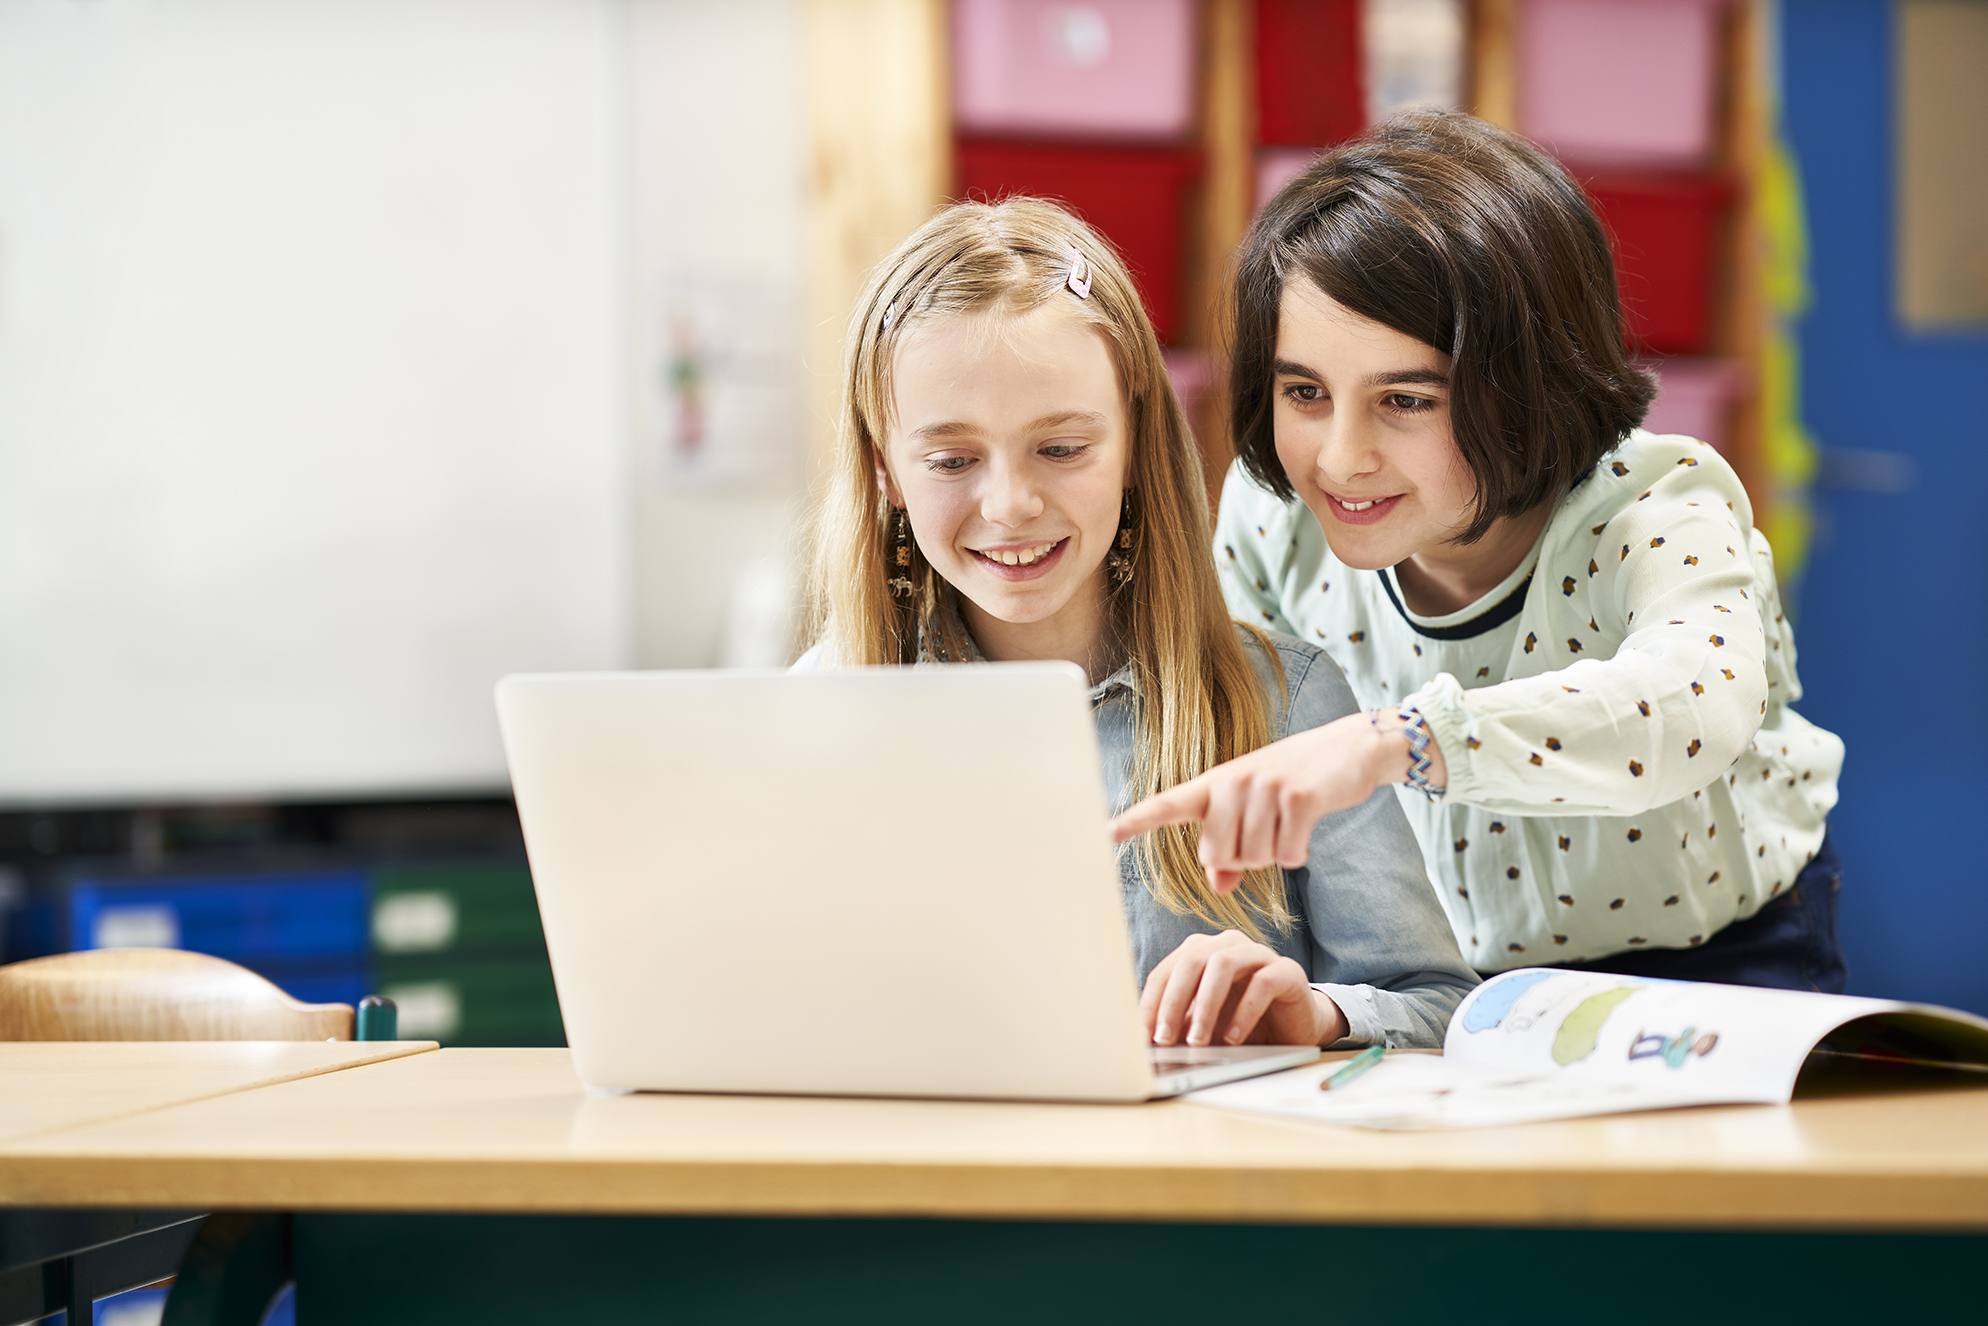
[1563, 833, 1849, 994]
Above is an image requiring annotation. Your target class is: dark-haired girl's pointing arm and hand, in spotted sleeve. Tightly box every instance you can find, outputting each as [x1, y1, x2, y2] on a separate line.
[1113, 439, 1805, 891]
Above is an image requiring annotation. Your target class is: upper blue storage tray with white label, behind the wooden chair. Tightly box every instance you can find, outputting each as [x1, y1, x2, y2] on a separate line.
[68, 871, 370, 968]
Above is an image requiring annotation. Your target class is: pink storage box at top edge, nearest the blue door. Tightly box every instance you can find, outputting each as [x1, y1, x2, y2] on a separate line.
[1519, 0, 1726, 167]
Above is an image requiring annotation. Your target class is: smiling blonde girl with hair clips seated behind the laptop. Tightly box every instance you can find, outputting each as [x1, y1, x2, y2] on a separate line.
[803, 199, 1475, 1046]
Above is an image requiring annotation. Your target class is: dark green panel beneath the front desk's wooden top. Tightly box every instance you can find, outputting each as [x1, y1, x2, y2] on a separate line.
[294, 1213, 1988, 1326]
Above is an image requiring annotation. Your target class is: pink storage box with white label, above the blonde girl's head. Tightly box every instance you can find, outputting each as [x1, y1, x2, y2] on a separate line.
[952, 0, 1195, 139]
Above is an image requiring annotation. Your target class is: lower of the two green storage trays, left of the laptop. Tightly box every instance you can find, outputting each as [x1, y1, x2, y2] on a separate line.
[374, 956, 567, 1046]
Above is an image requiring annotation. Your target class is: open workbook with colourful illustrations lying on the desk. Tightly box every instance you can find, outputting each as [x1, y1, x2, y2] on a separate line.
[1187, 968, 1988, 1129]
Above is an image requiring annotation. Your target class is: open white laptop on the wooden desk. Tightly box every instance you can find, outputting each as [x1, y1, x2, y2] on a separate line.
[497, 664, 1318, 1101]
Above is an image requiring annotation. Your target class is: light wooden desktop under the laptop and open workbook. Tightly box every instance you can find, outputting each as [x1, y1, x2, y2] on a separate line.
[0, 1050, 1988, 1231]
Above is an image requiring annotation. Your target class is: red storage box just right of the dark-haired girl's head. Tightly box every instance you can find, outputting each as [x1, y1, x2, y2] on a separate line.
[1580, 175, 1734, 354]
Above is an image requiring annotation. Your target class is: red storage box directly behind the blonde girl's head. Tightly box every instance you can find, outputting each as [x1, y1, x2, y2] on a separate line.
[954, 139, 1201, 340]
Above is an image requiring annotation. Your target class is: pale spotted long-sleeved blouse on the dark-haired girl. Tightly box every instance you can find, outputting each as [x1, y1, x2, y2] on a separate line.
[1215, 431, 1843, 972]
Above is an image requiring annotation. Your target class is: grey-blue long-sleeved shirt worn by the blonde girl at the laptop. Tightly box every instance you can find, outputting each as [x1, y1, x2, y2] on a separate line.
[1091, 632, 1477, 1048]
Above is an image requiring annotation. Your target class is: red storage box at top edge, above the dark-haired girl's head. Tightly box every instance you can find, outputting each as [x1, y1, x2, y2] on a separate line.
[1256, 0, 1366, 147]
